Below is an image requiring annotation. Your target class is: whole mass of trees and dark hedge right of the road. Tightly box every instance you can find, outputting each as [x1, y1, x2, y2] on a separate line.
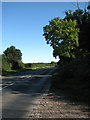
[43, 6, 90, 101]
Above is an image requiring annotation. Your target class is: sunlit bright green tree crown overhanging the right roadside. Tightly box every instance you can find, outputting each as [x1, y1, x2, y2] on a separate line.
[43, 17, 79, 59]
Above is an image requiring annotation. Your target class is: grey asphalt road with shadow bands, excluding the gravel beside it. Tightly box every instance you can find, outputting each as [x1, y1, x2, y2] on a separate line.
[2, 68, 55, 118]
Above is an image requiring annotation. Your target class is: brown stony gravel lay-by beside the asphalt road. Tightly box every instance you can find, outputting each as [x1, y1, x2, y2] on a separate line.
[28, 93, 90, 118]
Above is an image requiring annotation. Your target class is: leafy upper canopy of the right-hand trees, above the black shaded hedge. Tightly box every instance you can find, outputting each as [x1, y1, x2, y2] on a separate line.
[43, 7, 90, 62]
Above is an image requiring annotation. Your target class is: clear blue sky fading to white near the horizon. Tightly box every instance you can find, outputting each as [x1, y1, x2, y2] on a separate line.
[2, 2, 88, 63]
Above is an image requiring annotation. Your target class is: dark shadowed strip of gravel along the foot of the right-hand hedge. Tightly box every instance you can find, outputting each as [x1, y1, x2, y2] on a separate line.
[48, 89, 90, 114]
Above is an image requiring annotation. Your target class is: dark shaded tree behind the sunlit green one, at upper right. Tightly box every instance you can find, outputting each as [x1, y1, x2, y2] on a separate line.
[64, 6, 90, 51]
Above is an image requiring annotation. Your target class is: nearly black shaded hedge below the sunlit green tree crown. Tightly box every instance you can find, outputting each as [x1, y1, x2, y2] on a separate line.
[51, 55, 90, 102]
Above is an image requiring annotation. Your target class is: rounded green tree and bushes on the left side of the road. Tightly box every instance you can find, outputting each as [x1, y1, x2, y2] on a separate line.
[2, 46, 24, 71]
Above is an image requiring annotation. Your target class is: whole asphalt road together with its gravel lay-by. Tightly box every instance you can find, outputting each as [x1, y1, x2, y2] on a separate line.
[2, 68, 89, 120]
